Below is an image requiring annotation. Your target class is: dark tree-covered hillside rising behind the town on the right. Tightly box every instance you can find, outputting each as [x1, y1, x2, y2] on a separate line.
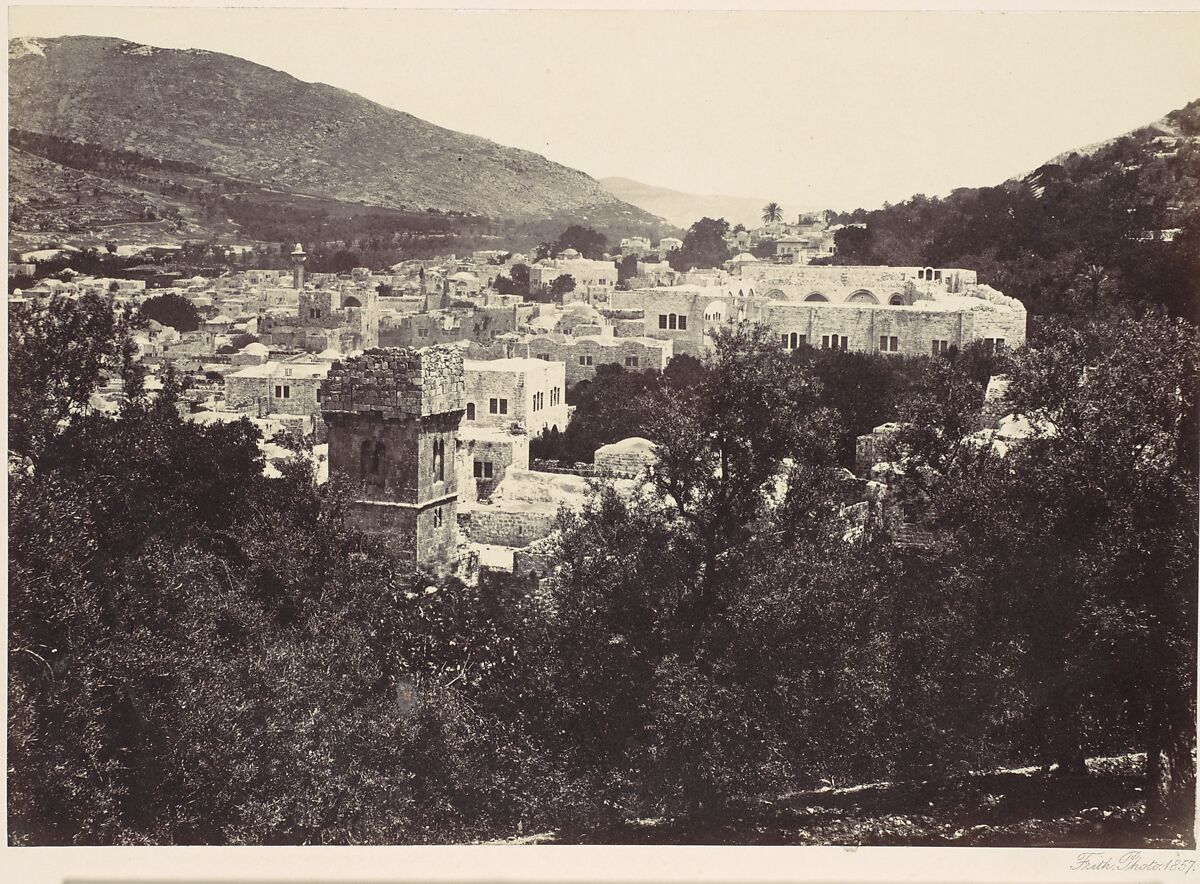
[834, 100, 1200, 317]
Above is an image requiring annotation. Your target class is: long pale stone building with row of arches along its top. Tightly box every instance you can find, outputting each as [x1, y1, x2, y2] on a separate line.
[613, 264, 1026, 356]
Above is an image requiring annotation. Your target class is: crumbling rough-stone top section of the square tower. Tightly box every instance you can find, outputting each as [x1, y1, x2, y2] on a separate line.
[320, 345, 466, 420]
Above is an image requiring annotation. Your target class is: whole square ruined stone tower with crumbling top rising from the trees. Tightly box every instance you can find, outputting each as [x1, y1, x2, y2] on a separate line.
[320, 347, 466, 572]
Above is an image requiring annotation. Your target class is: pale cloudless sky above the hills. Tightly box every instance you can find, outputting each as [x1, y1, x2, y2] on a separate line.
[10, 6, 1200, 214]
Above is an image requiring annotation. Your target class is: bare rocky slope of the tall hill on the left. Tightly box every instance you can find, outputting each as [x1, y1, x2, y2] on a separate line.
[8, 37, 658, 224]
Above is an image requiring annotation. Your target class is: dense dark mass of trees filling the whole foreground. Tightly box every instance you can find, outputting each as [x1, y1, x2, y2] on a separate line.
[8, 292, 1198, 844]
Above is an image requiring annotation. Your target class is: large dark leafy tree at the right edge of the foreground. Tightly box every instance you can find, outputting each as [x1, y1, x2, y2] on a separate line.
[916, 317, 1200, 824]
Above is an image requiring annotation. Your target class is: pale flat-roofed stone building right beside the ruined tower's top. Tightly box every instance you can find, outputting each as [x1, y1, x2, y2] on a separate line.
[463, 357, 568, 435]
